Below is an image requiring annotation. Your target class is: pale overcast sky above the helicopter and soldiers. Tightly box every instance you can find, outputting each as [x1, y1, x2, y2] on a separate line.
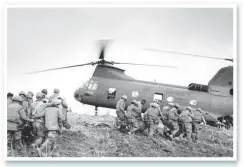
[7, 8, 233, 115]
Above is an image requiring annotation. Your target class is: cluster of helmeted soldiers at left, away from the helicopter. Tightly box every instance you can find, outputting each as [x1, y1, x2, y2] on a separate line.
[7, 88, 70, 156]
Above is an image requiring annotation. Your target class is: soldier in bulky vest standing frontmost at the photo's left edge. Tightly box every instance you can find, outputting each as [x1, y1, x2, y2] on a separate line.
[7, 96, 34, 153]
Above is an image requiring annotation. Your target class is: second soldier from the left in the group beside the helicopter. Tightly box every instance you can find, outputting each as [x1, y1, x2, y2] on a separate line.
[126, 100, 142, 133]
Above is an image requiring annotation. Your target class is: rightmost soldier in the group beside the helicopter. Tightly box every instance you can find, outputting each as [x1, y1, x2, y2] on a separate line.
[192, 108, 206, 142]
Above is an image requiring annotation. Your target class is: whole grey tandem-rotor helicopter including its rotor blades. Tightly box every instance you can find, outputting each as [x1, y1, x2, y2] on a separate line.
[29, 41, 233, 125]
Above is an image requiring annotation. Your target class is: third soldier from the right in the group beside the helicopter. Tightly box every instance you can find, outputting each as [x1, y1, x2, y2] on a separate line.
[166, 102, 180, 139]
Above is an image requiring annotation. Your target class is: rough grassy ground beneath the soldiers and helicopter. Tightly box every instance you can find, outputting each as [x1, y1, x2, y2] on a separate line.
[8, 113, 233, 157]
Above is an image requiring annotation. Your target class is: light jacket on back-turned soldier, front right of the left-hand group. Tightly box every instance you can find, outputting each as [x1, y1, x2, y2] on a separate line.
[34, 106, 65, 131]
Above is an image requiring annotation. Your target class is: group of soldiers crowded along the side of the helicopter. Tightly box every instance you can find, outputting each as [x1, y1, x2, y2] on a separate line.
[116, 95, 206, 142]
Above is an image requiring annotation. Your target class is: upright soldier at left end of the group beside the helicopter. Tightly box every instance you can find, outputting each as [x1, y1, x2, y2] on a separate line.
[116, 95, 127, 129]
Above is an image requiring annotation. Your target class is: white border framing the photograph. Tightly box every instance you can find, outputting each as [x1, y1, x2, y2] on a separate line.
[4, 3, 239, 161]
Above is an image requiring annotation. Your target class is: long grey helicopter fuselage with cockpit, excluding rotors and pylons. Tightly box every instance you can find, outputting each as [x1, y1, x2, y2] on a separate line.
[75, 76, 233, 122]
